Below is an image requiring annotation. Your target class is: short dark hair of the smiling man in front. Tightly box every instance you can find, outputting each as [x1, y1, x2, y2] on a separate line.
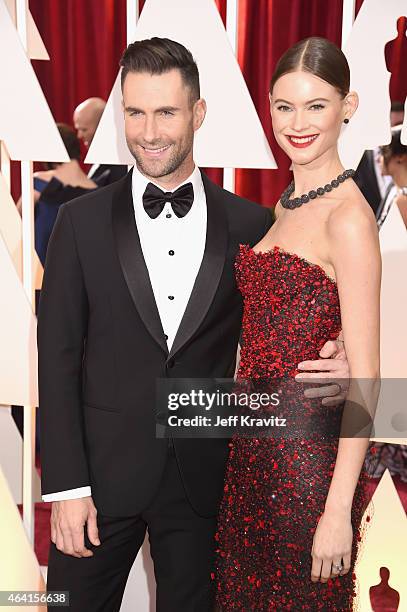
[120, 37, 201, 102]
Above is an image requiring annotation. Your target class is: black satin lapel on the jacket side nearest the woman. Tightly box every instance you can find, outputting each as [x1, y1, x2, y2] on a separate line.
[169, 173, 228, 357]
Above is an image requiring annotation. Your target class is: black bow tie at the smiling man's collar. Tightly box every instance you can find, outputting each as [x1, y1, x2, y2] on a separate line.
[143, 183, 194, 219]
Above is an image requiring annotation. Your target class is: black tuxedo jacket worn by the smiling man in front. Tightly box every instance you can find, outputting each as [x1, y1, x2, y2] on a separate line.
[38, 172, 272, 516]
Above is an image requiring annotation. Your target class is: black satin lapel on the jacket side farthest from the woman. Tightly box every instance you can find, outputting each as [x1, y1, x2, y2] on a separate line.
[112, 171, 168, 354]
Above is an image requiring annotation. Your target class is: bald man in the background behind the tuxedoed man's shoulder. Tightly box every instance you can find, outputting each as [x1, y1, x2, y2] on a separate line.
[73, 98, 127, 187]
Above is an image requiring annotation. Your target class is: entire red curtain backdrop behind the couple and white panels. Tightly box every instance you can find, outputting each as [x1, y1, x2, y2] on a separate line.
[29, 0, 402, 206]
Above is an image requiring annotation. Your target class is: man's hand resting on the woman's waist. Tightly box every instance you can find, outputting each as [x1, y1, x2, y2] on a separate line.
[295, 340, 350, 406]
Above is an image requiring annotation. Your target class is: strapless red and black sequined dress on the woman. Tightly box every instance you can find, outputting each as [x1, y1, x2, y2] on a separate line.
[214, 245, 366, 612]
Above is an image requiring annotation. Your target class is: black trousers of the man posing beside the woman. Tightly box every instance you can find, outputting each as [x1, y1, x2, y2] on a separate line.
[47, 446, 216, 612]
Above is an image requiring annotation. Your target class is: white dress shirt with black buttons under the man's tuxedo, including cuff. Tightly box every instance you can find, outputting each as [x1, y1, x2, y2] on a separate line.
[42, 166, 207, 502]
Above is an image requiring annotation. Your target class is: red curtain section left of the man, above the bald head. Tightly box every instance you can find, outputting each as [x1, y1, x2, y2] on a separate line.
[29, 0, 126, 165]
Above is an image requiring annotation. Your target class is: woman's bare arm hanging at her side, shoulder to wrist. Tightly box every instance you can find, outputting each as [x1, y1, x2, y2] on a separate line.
[327, 203, 381, 508]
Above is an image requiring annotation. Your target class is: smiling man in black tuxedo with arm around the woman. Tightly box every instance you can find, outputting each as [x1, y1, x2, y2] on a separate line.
[38, 38, 348, 612]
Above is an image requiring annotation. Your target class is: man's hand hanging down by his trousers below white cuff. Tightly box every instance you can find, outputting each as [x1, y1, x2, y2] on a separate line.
[50, 497, 100, 558]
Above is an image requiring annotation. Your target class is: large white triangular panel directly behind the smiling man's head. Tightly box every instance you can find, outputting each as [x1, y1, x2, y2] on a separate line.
[86, 0, 276, 168]
